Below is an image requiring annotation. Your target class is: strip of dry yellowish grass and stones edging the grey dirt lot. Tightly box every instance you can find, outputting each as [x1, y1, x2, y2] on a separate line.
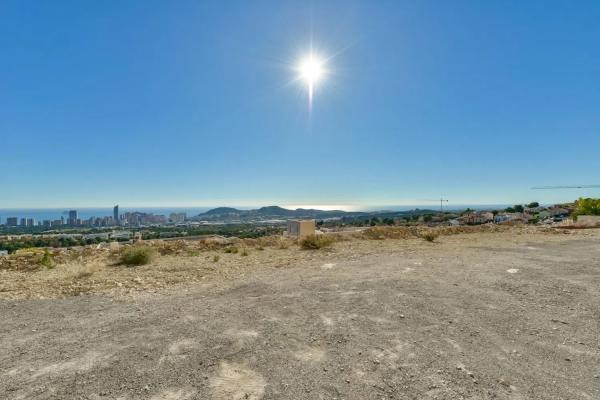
[0, 226, 600, 298]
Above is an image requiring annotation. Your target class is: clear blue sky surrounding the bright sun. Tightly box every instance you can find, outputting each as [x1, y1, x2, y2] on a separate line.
[0, 0, 600, 207]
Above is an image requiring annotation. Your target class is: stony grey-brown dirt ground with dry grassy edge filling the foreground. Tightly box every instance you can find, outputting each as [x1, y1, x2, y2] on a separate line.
[0, 230, 600, 400]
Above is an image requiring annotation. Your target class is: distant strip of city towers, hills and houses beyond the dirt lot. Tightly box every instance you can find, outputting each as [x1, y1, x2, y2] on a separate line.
[0, 199, 600, 255]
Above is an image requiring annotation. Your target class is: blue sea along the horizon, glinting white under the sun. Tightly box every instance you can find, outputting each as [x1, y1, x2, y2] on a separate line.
[0, 204, 508, 224]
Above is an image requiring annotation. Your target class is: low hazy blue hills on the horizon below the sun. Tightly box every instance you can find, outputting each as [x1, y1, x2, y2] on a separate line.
[194, 206, 437, 222]
